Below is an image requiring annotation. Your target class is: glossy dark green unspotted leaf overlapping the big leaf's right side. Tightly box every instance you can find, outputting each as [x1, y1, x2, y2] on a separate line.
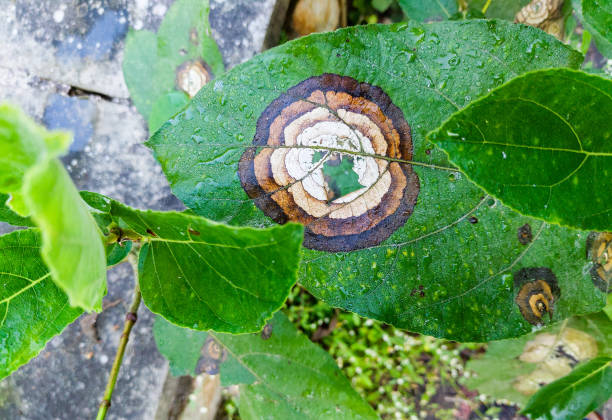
[429, 69, 612, 231]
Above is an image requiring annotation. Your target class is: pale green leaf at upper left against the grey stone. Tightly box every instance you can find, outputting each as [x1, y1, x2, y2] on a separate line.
[123, 0, 223, 128]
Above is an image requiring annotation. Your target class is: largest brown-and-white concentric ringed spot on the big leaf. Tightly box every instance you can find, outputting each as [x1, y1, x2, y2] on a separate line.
[239, 74, 419, 252]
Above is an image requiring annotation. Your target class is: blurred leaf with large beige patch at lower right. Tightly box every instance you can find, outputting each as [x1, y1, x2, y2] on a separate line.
[465, 312, 612, 405]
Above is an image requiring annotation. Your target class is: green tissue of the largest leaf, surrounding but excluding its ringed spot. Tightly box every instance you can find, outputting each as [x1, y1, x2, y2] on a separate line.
[148, 21, 605, 341]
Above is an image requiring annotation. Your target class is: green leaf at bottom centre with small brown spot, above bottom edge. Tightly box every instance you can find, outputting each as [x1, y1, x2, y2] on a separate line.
[155, 312, 378, 420]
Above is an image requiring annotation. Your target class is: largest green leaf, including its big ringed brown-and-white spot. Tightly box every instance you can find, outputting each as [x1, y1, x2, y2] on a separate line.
[148, 21, 605, 341]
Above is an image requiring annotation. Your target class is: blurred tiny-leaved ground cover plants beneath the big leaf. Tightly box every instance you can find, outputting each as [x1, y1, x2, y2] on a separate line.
[285, 287, 482, 420]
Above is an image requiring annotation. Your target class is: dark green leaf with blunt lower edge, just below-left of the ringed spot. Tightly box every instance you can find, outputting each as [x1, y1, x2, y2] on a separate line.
[86, 193, 303, 333]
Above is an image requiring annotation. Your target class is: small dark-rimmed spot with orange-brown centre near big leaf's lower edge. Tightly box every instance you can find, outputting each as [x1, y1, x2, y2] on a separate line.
[514, 267, 561, 325]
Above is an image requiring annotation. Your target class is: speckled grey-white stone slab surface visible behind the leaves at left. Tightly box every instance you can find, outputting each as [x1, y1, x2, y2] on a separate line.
[0, 0, 287, 420]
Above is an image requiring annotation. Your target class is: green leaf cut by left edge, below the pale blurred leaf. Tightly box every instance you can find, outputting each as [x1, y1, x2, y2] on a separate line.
[0, 230, 82, 379]
